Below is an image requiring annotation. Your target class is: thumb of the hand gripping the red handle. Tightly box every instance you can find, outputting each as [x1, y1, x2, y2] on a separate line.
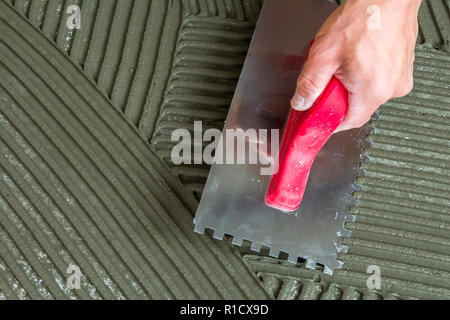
[291, 50, 338, 111]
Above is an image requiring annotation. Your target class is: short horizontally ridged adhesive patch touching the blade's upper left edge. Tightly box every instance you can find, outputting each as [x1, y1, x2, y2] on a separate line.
[152, 16, 253, 199]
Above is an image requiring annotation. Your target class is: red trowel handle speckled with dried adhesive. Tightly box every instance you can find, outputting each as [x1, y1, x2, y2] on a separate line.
[266, 77, 348, 212]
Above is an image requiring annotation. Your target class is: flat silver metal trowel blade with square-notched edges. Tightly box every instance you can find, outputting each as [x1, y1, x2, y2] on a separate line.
[194, 0, 368, 274]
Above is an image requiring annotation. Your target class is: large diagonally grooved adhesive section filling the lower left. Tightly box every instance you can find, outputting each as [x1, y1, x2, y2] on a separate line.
[0, 2, 265, 299]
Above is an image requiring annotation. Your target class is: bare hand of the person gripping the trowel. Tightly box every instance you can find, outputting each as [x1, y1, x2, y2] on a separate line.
[291, 0, 421, 132]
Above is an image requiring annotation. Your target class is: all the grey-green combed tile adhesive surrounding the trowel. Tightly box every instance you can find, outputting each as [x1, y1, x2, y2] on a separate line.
[0, 0, 450, 299]
